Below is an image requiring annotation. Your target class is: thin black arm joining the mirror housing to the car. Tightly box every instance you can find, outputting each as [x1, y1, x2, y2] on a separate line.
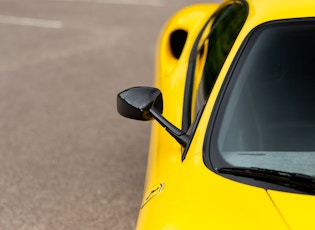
[149, 107, 190, 147]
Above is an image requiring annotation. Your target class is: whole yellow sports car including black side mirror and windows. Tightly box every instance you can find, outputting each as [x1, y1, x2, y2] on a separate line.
[117, 0, 315, 230]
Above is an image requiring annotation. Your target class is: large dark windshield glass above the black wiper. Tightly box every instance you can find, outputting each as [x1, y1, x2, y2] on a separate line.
[210, 20, 315, 176]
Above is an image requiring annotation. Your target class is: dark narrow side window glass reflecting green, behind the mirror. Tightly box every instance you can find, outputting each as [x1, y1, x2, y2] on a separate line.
[192, 3, 247, 115]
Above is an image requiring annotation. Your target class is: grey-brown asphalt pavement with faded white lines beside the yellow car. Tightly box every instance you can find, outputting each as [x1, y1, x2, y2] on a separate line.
[0, 0, 217, 230]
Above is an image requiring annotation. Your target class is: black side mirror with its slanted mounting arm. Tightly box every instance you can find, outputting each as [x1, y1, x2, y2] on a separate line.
[117, 87, 190, 147]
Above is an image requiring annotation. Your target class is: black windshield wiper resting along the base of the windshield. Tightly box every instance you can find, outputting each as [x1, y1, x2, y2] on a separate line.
[217, 167, 315, 194]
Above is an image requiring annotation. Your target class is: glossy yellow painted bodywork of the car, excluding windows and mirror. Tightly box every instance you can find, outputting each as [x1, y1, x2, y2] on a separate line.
[118, 0, 315, 230]
